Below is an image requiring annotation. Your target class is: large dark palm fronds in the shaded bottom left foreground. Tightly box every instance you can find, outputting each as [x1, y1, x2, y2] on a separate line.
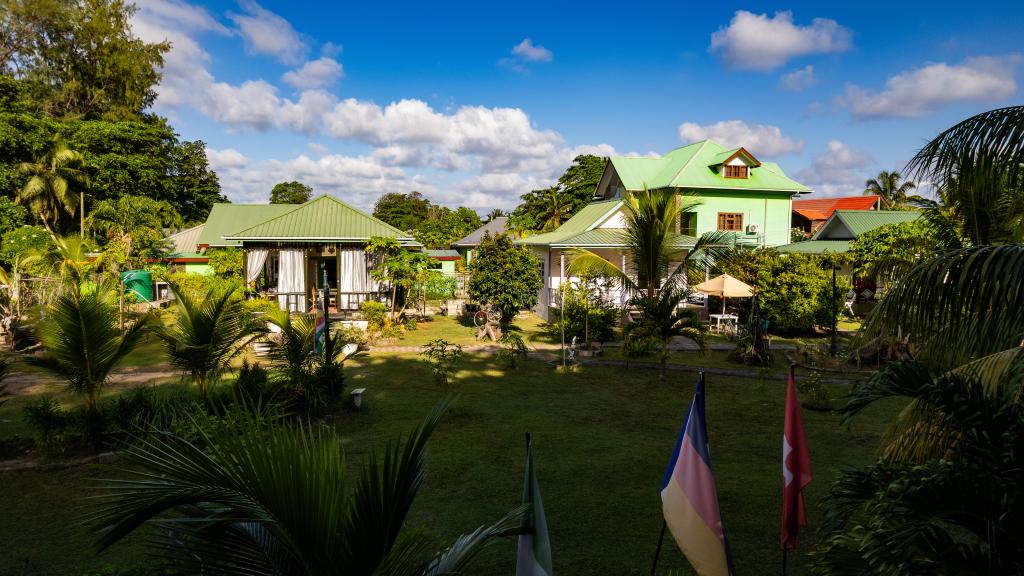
[89, 402, 525, 576]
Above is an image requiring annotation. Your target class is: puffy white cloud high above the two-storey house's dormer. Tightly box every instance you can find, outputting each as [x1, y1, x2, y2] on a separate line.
[709, 10, 852, 71]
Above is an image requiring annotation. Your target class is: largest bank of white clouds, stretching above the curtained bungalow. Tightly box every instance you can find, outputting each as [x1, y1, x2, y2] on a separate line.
[132, 0, 614, 210]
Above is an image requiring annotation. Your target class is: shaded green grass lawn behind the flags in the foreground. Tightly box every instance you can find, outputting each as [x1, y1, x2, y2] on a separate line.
[0, 348, 897, 575]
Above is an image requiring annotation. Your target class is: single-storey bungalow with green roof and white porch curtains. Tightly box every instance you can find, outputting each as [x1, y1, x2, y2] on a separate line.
[197, 196, 420, 312]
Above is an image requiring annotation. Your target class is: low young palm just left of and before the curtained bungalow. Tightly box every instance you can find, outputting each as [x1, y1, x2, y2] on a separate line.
[157, 286, 264, 399]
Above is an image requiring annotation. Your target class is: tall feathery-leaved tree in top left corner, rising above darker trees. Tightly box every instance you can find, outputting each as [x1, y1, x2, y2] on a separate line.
[0, 0, 170, 120]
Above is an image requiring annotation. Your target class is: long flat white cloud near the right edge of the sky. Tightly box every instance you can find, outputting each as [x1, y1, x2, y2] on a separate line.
[837, 56, 1019, 118]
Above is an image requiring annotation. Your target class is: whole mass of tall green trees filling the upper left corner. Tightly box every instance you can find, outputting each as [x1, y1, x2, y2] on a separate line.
[0, 0, 224, 241]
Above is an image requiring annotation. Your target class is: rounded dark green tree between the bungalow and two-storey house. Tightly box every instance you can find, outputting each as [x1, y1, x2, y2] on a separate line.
[469, 233, 541, 322]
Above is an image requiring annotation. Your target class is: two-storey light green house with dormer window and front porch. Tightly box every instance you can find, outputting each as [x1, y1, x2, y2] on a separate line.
[520, 140, 811, 318]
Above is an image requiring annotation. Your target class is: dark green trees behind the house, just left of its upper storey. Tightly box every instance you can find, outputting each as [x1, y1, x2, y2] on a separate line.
[509, 155, 606, 232]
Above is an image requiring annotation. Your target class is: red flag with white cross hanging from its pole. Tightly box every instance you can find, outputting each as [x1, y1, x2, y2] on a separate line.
[781, 367, 812, 549]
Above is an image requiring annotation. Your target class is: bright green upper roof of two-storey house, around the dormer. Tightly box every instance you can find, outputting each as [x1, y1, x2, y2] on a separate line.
[611, 140, 811, 194]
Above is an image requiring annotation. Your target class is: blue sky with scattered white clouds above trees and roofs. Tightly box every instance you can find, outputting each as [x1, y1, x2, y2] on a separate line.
[133, 0, 1024, 212]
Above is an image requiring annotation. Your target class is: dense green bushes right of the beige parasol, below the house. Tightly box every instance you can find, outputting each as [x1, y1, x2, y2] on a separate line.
[719, 249, 850, 332]
